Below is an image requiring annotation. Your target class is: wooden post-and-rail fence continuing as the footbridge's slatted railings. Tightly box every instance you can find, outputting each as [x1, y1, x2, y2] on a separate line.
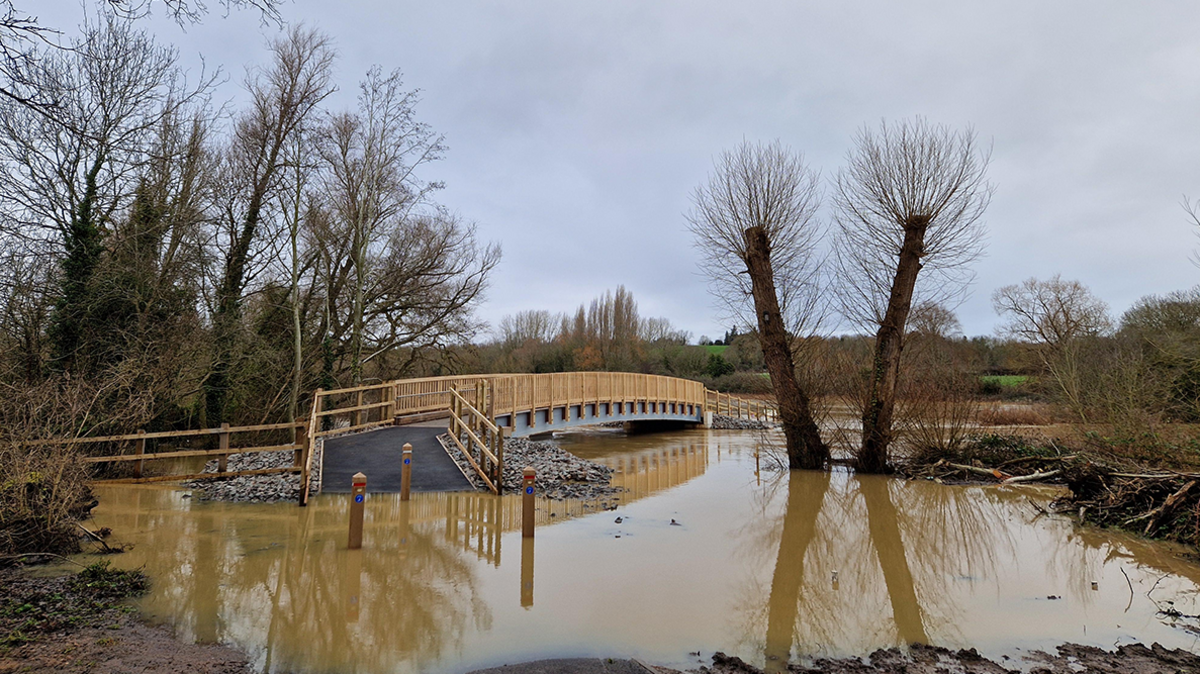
[30, 372, 778, 505]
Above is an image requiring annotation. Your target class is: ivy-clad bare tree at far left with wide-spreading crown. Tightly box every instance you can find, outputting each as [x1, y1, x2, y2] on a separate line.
[0, 17, 211, 371]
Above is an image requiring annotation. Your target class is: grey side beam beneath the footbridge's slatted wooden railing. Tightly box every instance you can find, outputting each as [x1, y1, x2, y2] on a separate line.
[496, 401, 704, 438]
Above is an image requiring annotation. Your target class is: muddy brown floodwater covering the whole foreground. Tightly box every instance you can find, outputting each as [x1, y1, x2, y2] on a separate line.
[75, 431, 1200, 673]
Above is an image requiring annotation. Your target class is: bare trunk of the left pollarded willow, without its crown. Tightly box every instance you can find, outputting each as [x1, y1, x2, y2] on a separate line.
[744, 227, 829, 469]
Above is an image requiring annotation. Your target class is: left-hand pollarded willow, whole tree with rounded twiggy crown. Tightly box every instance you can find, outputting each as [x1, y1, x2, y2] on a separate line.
[688, 142, 829, 469]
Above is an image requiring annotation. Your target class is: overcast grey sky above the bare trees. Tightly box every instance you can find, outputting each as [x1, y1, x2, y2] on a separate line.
[42, 0, 1200, 337]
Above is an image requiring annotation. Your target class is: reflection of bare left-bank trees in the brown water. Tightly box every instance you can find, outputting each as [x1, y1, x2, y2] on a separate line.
[93, 492, 502, 672]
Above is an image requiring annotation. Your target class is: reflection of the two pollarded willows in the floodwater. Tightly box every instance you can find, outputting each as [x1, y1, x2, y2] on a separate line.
[737, 471, 1016, 670]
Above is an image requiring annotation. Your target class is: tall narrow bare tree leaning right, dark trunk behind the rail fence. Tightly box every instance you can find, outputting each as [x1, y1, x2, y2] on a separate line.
[204, 26, 334, 425]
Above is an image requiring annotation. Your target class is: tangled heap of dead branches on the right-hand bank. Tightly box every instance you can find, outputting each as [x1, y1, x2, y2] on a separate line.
[1056, 463, 1200, 546]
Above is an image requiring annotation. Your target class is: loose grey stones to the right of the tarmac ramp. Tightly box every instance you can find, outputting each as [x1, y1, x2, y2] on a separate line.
[439, 435, 625, 500]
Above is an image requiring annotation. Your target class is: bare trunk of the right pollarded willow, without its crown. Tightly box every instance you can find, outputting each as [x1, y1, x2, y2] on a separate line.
[857, 217, 929, 473]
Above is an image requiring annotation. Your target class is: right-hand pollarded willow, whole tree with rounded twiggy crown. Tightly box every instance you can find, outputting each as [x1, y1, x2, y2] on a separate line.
[834, 118, 994, 473]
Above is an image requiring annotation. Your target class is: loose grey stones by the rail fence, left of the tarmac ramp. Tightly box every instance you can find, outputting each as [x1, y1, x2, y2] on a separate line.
[184, 438, 325, 504]
